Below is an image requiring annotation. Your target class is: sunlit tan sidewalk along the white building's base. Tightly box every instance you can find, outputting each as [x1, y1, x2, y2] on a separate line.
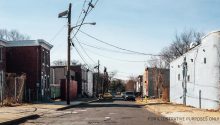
[136, 99, 220, 125]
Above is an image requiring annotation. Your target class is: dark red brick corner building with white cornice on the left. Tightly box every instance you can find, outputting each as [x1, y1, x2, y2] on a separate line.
[6, 39, 52, 101]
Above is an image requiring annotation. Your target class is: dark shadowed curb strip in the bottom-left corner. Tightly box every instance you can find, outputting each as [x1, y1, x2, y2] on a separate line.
[0, 114, 40, 125]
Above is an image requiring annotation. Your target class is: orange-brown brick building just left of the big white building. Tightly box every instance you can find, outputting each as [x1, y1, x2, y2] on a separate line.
[143, 67, 170, 100]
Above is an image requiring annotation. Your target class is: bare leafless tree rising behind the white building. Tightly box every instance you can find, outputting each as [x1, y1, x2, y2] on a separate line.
[160, 29, 204, 65]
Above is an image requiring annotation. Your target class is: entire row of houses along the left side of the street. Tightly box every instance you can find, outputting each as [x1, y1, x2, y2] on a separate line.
[0, 39, 105, 102]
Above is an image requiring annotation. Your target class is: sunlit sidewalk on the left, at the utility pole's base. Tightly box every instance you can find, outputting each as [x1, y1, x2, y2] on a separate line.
[0, 98, 97, 125]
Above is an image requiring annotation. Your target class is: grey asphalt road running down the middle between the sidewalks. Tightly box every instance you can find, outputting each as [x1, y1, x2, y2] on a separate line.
[22, 99, 179, 125]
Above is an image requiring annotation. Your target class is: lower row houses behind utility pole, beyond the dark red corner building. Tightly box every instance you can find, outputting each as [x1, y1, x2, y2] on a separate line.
[50, 65, 96, 99]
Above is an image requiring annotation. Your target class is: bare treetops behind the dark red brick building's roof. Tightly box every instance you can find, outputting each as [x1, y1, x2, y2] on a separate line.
[0, 29, 30, 41]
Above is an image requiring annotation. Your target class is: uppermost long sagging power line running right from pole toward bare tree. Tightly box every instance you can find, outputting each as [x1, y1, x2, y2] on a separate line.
[78, 30, 161, 56]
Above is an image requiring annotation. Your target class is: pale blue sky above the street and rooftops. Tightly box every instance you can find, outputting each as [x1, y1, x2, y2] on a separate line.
[0, 0, 220, 78]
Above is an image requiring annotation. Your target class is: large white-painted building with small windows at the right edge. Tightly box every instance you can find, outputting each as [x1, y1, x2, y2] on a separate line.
[170, 31, 220, 109]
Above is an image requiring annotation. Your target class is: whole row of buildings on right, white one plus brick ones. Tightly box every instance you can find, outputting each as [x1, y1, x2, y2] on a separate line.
[135, 31, 220, 109]
